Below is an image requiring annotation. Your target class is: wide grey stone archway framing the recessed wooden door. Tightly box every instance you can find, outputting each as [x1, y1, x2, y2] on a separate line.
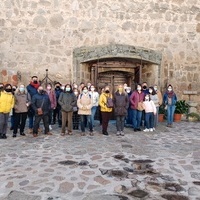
[73, 44, 162, 89]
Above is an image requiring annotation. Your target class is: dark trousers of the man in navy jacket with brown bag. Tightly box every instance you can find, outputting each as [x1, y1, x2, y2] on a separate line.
[33, 114, 49, 134]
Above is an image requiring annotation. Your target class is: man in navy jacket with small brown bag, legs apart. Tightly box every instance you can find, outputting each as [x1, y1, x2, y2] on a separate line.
[31, 86, 52, 137]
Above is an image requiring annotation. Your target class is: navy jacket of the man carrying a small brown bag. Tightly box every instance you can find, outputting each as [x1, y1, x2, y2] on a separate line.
[31, 93, 51, 115]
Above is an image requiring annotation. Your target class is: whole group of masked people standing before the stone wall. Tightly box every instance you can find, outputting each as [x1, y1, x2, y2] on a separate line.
[0, 76, 177, 139]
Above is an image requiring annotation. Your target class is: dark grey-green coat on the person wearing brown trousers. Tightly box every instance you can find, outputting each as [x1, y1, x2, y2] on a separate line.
[58, 92, 77, 112]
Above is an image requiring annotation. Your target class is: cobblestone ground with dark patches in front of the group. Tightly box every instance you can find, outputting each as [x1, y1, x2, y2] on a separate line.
[0, 121, 200, 200]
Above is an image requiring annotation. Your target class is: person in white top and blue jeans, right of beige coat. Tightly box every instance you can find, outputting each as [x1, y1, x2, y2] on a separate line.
[89, 85, 99, 132]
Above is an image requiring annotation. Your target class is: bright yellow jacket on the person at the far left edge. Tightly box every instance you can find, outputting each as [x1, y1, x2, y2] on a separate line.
[0, 91, 14, 113]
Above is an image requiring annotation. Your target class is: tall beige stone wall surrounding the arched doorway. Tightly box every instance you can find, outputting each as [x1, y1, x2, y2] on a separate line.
[0, 0, 200, 108]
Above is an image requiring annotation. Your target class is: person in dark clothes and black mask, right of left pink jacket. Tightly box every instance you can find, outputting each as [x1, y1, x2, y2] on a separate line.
[53, 82, 62, 127]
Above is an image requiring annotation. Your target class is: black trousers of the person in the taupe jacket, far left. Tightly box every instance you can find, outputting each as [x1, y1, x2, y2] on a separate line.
[13, 112, 27, 134]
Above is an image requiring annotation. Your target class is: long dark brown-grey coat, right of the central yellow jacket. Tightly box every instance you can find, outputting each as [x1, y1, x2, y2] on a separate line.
[113, 92, 129, 116]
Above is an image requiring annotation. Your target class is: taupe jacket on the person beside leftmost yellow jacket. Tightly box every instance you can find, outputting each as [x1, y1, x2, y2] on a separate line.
[14, 92, 31, 113]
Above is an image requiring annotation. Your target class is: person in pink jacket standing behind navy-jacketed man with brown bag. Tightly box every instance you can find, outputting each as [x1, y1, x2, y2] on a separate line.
[46, 83, 57, 130]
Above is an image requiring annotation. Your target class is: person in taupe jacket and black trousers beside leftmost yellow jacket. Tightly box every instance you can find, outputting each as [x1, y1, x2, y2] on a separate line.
[13, 84, 31, 137]
